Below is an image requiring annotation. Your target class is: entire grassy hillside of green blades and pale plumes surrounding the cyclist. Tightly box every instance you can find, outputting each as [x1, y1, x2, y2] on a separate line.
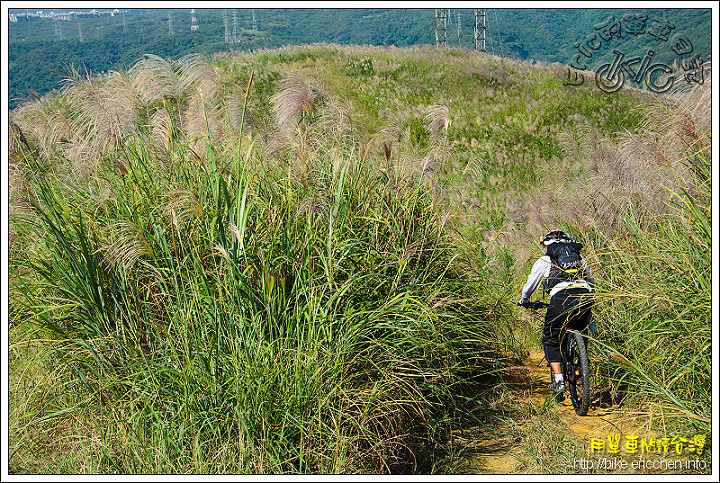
[10, 45, 711, 473]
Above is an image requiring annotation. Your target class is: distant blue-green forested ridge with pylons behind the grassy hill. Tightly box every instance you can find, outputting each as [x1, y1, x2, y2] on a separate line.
[7, 8, 712, 108]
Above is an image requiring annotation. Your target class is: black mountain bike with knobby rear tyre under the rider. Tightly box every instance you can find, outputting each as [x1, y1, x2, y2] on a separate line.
[518, 302, 590, 416]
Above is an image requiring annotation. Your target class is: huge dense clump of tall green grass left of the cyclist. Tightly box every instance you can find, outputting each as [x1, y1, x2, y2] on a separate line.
[11, 57, 510, 473]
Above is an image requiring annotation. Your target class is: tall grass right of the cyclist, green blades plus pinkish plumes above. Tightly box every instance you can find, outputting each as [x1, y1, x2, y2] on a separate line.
[574, 73, 712, 432]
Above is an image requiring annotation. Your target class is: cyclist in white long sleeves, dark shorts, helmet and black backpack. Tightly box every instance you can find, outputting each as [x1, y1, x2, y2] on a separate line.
[520, 230, 595, 393]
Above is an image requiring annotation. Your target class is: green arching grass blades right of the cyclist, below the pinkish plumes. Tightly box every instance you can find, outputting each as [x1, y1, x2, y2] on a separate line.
[588, 156, 712, 431]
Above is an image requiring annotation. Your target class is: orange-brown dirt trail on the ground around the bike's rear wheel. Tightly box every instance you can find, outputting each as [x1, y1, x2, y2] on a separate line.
[455, 351, 636, 474]
